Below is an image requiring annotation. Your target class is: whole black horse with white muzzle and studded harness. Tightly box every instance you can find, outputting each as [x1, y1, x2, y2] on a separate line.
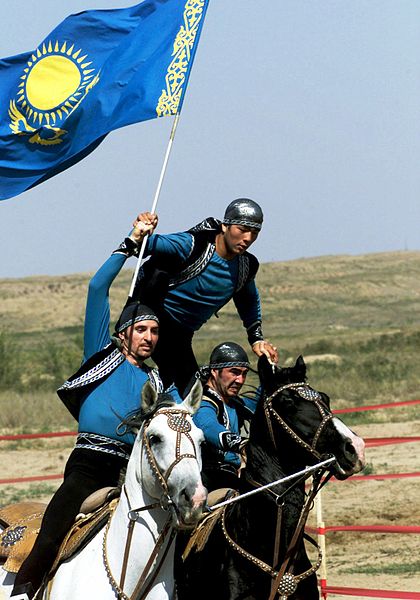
[175, 357, 364, 600]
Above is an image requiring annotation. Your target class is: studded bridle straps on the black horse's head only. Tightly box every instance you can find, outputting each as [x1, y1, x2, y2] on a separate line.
[264, 382, 333, 460]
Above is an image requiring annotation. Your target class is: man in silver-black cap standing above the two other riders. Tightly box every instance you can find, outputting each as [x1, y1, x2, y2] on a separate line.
[133, 198, 275, 394]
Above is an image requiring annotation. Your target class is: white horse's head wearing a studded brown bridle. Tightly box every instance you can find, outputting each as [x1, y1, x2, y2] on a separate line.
[130, 381, 207, 528]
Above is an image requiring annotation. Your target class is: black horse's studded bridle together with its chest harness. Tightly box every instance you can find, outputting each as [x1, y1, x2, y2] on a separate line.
[221, 382, 333, 600]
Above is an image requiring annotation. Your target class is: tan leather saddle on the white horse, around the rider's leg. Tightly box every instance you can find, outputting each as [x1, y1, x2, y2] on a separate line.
[0, 487, 120, 573]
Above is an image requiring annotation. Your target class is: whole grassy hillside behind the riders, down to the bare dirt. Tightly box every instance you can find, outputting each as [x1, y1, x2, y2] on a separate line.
[0, 247, 420, 416]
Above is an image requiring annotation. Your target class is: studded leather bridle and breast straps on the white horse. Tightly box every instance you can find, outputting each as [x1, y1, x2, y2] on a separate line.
[102, 407, 197, 600]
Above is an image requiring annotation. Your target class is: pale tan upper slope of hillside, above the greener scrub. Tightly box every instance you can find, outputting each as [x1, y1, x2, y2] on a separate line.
[0, 252, 420, 339]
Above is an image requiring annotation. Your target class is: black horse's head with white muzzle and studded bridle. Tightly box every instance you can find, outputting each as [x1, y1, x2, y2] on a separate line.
[258, 356, 364, 479]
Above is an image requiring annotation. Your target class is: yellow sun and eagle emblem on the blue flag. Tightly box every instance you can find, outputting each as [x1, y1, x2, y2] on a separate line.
[9, 41, 99, 146]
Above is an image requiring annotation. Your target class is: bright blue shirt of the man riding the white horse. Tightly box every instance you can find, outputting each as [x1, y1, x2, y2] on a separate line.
[79, 254, 181, 444]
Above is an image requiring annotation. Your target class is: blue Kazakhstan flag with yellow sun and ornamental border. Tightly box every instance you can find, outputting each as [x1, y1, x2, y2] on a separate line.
[0, 0, 209, 200]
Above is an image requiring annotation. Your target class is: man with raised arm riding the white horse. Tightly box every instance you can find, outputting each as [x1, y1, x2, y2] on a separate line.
[11, 218, 169, 600]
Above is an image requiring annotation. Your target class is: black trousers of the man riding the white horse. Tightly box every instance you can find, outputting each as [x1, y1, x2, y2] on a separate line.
[15, 448, 127, 591]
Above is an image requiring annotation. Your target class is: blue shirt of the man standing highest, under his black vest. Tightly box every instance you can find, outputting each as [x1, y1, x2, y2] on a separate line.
[145, 232, 261, 331]
